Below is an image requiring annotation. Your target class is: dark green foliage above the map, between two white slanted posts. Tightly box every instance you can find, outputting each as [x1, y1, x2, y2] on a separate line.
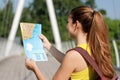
[21, 0, 54, 42]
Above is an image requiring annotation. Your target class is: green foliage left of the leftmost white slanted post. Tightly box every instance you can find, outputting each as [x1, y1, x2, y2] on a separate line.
[0, 1, 13, 38]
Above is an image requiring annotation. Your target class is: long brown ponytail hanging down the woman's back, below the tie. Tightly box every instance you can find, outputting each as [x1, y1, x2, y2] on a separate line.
[88, 11, 115, 78]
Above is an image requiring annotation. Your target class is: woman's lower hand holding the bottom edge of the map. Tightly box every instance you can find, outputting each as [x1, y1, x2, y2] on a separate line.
[25, 59, 37, 71]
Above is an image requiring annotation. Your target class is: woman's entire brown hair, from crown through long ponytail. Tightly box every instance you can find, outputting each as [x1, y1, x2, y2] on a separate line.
[71, 6, 115, 78]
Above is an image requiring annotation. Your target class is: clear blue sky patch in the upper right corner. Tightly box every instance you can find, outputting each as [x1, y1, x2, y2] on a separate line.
[95, 0, 120, 20]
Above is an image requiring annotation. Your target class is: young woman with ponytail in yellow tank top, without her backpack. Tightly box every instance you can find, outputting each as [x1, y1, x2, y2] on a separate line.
[26, 6, 115, 80]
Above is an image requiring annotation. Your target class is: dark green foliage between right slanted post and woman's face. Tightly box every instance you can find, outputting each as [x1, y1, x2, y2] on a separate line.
[53, 0, 84, 41]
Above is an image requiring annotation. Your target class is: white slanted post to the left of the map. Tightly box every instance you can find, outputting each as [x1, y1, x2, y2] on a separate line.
[5, 0, 24, 56]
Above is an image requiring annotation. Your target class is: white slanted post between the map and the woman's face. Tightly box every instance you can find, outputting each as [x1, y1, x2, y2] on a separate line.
[46, 0, 62, 50]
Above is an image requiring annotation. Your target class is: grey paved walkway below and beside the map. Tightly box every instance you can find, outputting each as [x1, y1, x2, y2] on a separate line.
[0, 55, 120, 80]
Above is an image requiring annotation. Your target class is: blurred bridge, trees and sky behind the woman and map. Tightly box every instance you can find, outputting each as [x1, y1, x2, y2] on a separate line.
[0, 0, 120, 80]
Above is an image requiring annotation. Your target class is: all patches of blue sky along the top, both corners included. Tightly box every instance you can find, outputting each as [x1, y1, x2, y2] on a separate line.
[0, 0, 120, 20]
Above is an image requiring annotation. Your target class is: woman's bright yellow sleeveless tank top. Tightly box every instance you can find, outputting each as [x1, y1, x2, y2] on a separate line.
[71, 44, 94, 80]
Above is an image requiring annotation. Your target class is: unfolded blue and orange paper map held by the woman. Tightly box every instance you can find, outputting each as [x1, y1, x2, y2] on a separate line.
[20, 23, 48, 61]
